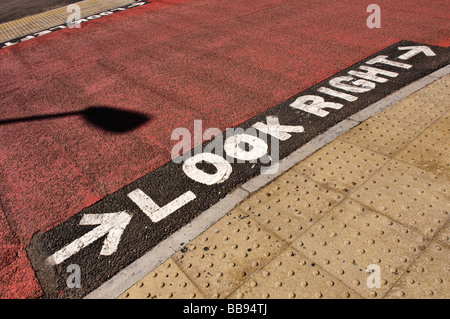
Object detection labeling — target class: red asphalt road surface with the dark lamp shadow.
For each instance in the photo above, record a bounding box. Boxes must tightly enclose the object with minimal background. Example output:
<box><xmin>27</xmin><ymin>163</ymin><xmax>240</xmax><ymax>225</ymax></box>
<box><xmin>0</xmin><ymin>0</ymin><xmax>450</xmax><ymax>298</ymax></box>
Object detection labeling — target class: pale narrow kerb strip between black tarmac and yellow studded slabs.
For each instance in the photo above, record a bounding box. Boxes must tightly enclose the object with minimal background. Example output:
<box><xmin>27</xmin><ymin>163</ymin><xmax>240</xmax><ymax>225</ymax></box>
<box><xmin>85</xmin><ymin>64</ymin><xmax>450</xmax><ymax>299</ymax></box>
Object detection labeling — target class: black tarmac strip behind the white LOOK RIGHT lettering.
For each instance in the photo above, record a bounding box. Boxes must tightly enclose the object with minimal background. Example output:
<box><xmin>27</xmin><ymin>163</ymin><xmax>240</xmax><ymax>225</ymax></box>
<box><xmin>27</xmin><ymin>41</ymin><xmax>450</xmax><ymax>298</ymax></box>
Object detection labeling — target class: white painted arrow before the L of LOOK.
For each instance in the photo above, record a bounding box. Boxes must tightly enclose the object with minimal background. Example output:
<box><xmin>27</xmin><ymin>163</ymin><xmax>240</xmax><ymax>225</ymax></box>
<box><xmin>46</xmin><ymin>211</ymin><xmax>132</xmax><ymax>266</ymax></box>
